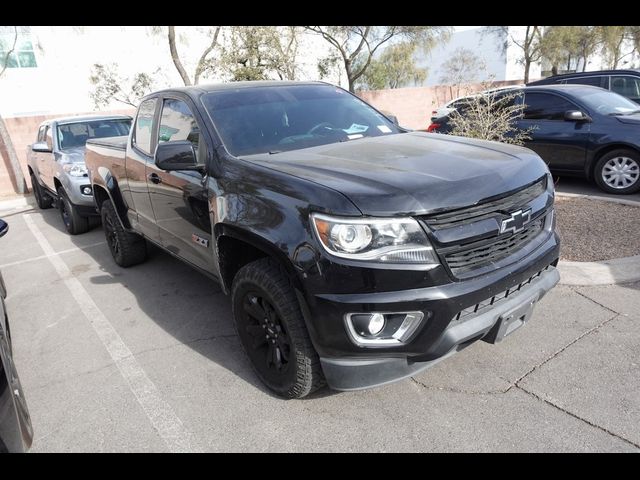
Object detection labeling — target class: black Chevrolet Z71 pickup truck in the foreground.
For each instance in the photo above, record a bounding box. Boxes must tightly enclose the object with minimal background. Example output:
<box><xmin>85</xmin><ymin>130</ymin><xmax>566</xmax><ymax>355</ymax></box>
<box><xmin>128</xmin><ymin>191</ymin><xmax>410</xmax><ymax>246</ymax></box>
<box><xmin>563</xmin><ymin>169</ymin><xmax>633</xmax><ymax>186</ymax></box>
<box><xmin>86</xmin><ymin>82</ymin><xmax>559</xmax><ymax>398</ymax></box>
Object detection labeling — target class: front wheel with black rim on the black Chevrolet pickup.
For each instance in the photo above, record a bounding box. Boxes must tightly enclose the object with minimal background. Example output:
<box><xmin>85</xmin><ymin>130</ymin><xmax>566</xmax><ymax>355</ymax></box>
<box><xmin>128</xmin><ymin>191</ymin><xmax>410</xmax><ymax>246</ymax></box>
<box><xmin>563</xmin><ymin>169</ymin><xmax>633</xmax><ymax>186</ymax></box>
<box><xmin>231</xmin><ymin>258</ymin><xmax>325</xmax><ymax>398</ymax></box>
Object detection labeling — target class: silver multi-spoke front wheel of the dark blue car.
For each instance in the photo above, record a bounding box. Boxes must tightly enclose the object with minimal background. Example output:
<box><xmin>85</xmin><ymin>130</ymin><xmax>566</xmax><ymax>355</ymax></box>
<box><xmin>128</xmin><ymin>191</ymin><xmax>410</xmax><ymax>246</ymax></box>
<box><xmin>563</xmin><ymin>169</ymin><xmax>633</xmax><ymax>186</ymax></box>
<box><xmin>594</xmin><ymin>148</ymin><xmax>640</xmax><ymax>195</ymax></box>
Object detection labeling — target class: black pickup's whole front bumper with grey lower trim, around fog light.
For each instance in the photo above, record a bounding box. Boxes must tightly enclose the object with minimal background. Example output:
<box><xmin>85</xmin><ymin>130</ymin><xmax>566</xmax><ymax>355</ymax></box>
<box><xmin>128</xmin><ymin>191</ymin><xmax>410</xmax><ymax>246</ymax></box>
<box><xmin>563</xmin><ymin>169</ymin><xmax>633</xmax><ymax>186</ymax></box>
<box><xmin>299</xmin><ymin>228</ymin><xmax>560</xmax><ymax>390</ymax></box>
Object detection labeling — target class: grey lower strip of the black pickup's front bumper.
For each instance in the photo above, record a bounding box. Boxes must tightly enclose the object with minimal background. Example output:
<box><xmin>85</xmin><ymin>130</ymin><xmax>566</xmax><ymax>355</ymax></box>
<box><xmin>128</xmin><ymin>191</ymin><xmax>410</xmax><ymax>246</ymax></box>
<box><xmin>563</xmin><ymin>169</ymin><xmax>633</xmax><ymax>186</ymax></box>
<box><xmin>320</xmin><ymin>266</ymin><xmax>560</xmax><ymax>390</ymax></box>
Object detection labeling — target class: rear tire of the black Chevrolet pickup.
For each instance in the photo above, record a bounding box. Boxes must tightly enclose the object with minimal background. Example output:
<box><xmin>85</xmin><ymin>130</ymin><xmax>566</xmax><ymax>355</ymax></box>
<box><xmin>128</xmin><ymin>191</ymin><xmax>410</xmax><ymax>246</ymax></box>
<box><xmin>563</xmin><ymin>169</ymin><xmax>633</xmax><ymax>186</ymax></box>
<box><xmin>100</xmin><ymin>200</ymin><xmax>147</xmax><ymax>268</ymax></box>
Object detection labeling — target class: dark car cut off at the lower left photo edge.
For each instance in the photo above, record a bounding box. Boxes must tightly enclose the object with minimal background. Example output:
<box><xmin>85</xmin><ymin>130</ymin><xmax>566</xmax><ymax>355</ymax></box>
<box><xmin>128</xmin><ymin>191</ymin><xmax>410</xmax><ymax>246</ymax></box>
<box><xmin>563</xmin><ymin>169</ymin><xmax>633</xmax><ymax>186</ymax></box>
<box><xmin>0</xmin><ymin>220</ymin><xmax>33</xmax><ymax>453</ymax></box>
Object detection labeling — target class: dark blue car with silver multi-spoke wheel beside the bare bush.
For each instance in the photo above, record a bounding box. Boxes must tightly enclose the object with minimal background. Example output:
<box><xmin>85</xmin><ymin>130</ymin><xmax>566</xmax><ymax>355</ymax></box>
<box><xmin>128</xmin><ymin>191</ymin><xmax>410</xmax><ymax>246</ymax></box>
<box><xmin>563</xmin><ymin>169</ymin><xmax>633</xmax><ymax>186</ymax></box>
<box><xmin>432</xmin><ymin>85</ymin><xmax>640</xmax><ymax>194</ymax></box>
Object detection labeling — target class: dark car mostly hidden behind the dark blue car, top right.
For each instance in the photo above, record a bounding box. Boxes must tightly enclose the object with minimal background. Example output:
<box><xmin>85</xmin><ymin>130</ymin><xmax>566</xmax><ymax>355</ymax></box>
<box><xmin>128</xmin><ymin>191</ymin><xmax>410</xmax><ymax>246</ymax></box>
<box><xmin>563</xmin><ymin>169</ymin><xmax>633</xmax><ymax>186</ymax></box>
<box><xmin>527</xmin><ymin>70</ymin><xmax>640</xmax><ymax>103</ymax></box>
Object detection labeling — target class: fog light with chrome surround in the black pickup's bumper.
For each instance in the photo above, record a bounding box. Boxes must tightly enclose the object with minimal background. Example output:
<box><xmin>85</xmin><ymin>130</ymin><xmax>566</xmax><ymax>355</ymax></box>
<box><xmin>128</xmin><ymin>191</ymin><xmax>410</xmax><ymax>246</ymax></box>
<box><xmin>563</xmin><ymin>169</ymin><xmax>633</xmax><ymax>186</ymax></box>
<box><xmin>345</xmin><ymin>312</ymin><xmax>429</xmax><ymax>347</ymax></box>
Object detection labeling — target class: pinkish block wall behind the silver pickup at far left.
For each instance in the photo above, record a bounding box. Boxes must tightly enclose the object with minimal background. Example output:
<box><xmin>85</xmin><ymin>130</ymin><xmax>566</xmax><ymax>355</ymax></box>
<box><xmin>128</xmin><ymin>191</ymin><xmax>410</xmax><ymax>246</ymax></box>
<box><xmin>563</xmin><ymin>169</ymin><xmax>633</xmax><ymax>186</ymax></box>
<box><xmin>0</xmin><ymin>108</ymin><xmax>135</xmax><ymax>197</ymax></box>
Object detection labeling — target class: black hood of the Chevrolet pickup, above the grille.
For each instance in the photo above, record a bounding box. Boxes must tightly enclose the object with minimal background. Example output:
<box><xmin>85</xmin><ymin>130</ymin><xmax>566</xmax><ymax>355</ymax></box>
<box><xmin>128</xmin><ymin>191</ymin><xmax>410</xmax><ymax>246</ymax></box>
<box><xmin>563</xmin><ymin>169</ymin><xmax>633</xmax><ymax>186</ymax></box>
<box><xmin>243</xmin><ymin>132</ymin><xmax>548</xmax><ymax>216</ymax></box>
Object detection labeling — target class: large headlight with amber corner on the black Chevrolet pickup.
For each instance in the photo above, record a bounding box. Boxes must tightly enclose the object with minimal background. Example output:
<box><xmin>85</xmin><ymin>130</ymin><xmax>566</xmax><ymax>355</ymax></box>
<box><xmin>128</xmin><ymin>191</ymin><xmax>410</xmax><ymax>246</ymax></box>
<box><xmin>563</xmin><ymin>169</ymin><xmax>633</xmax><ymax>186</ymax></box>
<box><xmin>311</xmin><ymin>213</ymin><xmax>439</xmax><ymax>267</ymax></box>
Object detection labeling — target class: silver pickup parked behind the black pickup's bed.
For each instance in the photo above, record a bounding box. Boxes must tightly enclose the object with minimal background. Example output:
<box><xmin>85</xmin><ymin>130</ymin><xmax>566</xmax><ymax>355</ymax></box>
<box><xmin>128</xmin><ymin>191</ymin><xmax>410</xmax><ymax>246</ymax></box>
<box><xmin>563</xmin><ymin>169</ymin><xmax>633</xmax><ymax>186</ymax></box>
<box><xmin>28</xmin><ymin>115</ymin><xmax>131</xmax><ymax>235</ymax></box>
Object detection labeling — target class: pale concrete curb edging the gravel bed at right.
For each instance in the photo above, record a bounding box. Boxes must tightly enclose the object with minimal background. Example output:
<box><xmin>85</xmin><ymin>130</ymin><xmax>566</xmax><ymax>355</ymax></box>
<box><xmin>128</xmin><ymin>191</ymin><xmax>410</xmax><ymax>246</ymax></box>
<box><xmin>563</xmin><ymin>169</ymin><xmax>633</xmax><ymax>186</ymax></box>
<box><xmin>556</xmin><ymin>192</ymin><xmax>640</xmax><ymax>286</ymax></box>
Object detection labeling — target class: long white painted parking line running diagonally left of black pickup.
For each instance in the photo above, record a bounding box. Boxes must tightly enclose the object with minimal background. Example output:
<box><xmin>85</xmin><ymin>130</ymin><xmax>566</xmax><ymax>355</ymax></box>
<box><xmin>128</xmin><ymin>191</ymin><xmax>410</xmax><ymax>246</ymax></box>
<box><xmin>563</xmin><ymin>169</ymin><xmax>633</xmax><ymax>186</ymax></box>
<box><xmin>22</xmin><ymin>215</ymin><xmax>200</xmax><ymax>452</ymax></box>
